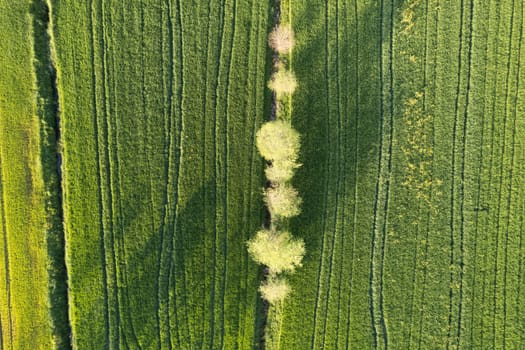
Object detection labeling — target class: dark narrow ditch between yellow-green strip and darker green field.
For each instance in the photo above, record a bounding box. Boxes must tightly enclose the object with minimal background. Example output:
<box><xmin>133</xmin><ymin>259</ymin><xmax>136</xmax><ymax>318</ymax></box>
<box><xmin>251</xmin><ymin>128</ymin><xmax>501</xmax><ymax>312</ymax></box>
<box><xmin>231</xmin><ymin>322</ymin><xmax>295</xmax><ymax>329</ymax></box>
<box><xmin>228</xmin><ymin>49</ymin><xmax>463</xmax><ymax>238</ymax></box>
<box><xmin>30</xmin><ymin>0</ymin><xmax>71</xmax><ymax>349</ymax></box>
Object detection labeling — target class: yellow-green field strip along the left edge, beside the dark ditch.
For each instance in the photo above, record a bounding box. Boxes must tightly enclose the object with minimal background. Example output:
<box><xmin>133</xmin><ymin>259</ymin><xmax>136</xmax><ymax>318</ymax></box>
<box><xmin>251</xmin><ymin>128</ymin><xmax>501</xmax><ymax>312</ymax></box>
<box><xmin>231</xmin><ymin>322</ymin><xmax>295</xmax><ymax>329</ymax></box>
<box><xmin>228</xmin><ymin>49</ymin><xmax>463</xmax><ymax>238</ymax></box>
<box><xmin>0</xmin><ymin>1</ymin><xmax>53</xmax><ymax>349</ymax></box>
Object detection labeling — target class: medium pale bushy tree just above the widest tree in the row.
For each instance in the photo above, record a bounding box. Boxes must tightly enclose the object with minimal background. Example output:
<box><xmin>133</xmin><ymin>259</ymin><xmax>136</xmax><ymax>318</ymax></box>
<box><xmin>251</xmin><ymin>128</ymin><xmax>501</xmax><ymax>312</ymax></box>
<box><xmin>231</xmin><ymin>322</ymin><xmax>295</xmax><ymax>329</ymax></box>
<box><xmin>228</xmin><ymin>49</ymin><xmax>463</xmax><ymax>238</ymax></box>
<box><xmin>264</xmin><ymin>185</ymin><xmax>302</xmax><ymax>218</ymax></box>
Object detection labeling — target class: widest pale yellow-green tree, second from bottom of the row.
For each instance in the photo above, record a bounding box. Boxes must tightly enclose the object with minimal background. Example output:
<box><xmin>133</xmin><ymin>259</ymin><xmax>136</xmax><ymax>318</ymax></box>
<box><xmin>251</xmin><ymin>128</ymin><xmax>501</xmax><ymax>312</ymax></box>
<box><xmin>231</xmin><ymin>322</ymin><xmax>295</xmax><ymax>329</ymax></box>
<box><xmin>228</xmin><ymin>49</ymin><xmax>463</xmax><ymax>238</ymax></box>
<box><xmin>248</xmin><ymin>230</ymin><xmax>305</xmax><ymax>275</ymax></box>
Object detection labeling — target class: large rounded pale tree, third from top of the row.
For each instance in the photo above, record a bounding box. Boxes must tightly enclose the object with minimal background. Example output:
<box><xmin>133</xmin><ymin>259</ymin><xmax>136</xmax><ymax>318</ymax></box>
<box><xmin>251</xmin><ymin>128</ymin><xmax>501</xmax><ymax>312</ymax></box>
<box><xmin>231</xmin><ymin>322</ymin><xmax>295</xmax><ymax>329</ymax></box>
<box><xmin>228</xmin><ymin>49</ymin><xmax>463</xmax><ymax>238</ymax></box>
<box><xmin>256</xmin><ymin>120</ymin><xmax>300</xmax><ymax>163</ymax></box>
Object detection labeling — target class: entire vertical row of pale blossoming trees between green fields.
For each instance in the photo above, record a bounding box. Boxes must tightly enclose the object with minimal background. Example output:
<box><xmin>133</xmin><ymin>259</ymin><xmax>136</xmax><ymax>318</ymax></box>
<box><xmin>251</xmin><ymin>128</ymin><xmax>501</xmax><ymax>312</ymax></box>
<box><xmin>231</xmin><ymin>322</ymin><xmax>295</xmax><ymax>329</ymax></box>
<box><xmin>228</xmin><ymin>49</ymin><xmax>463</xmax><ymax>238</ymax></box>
<box><xmin>248</xmin><ymin>25</ymin><xmax>305</xmax><ymax>304</ymax></box>
